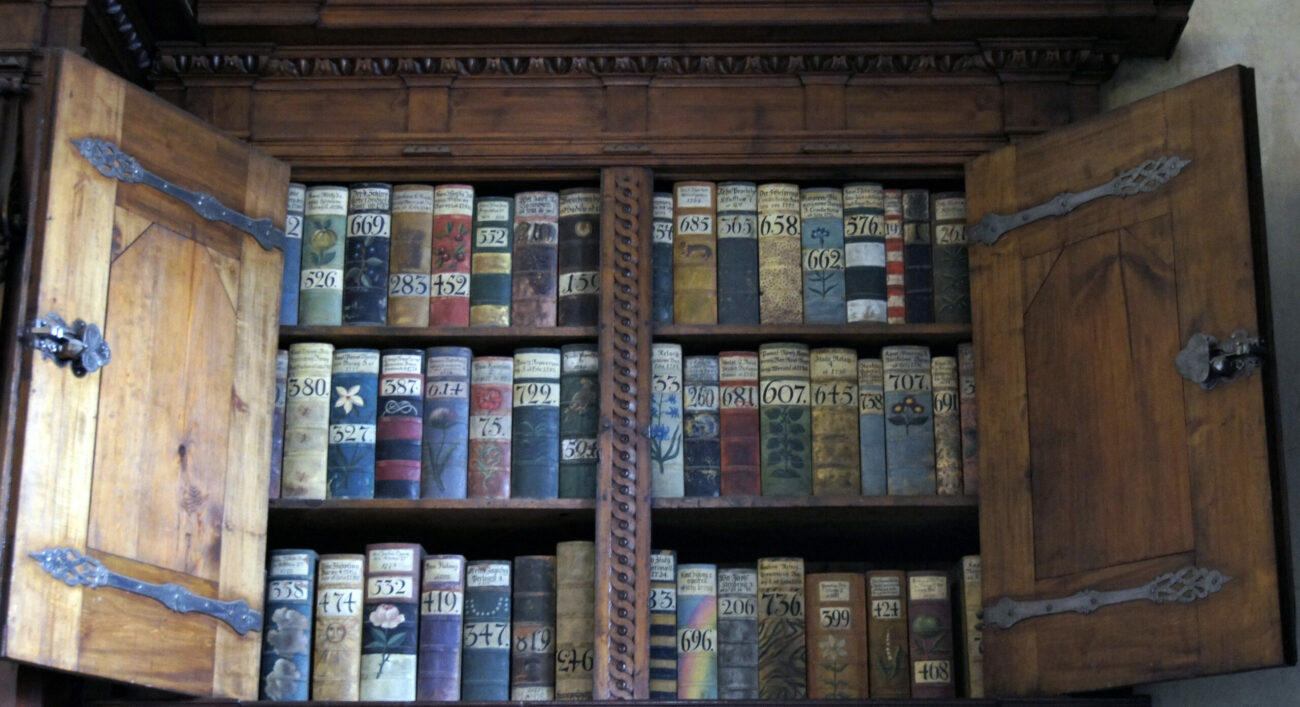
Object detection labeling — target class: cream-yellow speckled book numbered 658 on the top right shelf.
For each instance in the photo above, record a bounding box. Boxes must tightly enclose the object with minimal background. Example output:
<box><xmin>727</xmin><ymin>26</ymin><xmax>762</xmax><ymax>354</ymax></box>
<box><xmin>758</xmin><ymin>183</ymin><xmax>803</xmax><ymax>324</ymax></box>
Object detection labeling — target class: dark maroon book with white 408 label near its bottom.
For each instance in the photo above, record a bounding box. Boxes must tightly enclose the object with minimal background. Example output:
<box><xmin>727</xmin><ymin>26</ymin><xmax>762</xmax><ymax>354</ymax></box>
<box><xmin>907</xmin><ymin>571</ymin><xmax>957</xmax><ymax>698</ymax></box>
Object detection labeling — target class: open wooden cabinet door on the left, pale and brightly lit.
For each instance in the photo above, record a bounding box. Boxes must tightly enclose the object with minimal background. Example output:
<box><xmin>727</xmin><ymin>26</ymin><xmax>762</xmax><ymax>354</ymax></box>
<box><xmin>4</xmin><ymin>53</ymin><xmax>289</xmax><ymax>698</ymax></box>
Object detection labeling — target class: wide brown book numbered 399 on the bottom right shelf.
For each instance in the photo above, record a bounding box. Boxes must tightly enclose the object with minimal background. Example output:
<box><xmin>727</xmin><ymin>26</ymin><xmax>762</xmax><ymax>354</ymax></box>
<box><xmin>803</xmin><ymin>572</ymin><xmax>868</xmax><ymax>699</ymax></box>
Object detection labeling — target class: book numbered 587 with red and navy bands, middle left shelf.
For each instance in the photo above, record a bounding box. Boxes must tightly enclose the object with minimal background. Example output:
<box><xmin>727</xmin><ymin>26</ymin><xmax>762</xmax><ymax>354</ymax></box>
<box><xmin>374</xmin><ymin>348</ymin><xmax>424</xmax><ymax>498</ymax></box>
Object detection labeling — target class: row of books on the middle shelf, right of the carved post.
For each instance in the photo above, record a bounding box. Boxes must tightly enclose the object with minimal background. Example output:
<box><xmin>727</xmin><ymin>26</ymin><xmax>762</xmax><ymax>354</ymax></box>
<box><xmin>649</xmin><ymin>343</ymin><xmax>979</xmax><ymax>498</ymax></box>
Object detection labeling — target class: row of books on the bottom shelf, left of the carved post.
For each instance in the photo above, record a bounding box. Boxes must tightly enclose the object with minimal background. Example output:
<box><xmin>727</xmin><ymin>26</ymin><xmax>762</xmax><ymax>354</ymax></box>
<box><xmin>259</xmin><ymin>541</ymin><xmax>595</xmax><ymax>702</ymax></box>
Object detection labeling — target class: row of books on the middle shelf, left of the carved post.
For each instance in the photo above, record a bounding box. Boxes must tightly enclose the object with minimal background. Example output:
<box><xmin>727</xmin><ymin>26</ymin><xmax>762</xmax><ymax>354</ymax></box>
<box><xmin>270</xmin><ymin>343</ymin><xmax>599</xmax><ymax>499</ymax></box>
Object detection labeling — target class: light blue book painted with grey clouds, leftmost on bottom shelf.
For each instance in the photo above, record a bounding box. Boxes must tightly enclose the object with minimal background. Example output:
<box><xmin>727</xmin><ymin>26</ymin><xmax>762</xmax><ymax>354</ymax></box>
<box><xmin>259</xmin><ymin>550</ymin><xmax>316</xmax><ymax>701</ymax></box>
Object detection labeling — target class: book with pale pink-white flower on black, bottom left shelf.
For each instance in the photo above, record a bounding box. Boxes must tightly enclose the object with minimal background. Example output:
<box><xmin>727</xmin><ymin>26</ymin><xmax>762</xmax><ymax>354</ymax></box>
<box><xmin>360</xmin><ymin>542</ymin><xmax>424</xmax><ymax>702</ymax></box>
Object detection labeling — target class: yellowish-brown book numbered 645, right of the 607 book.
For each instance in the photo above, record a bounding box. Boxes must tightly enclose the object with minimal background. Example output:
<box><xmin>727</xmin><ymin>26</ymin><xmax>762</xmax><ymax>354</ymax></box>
<box><xmin>810</xmin><ymin>348</ymin><xmax>862</xmax><ymax>496</ymax></box>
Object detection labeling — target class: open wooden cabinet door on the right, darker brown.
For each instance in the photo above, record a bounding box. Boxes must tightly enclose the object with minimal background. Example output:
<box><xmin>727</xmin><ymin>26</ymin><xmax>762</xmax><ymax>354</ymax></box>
<box><xmin>966</xmin><ymin>68</ymin><xmax>1291</xmax><ymax>694</ymax></box>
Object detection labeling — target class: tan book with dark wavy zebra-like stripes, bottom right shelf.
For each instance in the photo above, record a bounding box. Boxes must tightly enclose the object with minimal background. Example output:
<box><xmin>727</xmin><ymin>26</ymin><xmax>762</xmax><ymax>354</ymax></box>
<box><xmin>758</xmin><ymin>558</ymin><xmax>807</xmax><ymax>699</ymax></box>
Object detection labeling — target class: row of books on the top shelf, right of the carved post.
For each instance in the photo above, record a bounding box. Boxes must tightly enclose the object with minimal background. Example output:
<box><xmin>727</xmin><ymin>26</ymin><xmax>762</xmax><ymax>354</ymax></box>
<box><xmin>653</xmin><ymin>182</ymin><xmax>970</xmax><ymax>325</ymax></box>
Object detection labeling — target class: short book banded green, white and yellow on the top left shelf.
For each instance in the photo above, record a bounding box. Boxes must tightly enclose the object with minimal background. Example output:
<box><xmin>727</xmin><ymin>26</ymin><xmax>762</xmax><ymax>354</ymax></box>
<box><xmin>469</xmin><ymin>196</ymin><xmax>515</xmax><ymax>326</ymax></box>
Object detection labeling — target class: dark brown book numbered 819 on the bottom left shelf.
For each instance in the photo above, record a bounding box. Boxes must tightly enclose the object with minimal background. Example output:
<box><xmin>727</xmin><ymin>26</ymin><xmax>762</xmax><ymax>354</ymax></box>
<box><xmin>510</xmin><ymin>555</ymin><xmax>555</xmax><ymax>702</ymax></box>
